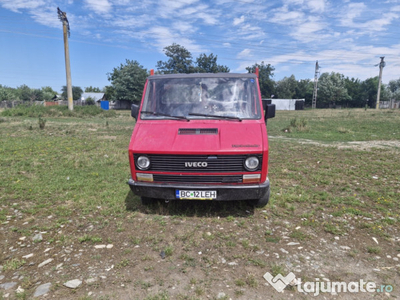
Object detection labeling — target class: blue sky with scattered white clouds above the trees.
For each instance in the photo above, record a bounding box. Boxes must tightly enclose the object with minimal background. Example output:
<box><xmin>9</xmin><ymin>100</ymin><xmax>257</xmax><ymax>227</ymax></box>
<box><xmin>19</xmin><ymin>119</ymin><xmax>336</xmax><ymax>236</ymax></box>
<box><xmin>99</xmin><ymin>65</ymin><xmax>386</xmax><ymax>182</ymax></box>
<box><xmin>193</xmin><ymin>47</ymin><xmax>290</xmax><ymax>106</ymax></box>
<box><xmin>0</xmin><ymin>0</ymin><xmax>400</xmax><ymax>91</ymax></box>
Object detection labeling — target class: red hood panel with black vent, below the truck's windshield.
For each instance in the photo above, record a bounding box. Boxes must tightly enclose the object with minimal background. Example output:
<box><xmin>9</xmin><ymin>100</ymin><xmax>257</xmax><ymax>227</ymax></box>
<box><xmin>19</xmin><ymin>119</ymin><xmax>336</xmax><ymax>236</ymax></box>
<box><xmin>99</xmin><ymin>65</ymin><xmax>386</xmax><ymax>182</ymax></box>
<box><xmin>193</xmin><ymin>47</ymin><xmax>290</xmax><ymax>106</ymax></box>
<box><xmin>129</xmin><ymin>121</ymin><xmax>265</xmax><ymax>154</ymax></box>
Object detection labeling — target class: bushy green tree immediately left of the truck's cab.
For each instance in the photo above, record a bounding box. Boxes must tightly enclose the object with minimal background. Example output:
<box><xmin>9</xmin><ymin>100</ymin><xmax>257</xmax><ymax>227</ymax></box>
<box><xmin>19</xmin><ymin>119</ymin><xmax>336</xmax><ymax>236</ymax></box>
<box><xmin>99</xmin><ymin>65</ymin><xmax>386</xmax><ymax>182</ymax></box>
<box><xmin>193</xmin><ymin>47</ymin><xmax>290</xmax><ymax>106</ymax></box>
<box><xmin>106</xmin><ymin>59</ymin><xmax>148</xmax><ymax>102</ymax></box>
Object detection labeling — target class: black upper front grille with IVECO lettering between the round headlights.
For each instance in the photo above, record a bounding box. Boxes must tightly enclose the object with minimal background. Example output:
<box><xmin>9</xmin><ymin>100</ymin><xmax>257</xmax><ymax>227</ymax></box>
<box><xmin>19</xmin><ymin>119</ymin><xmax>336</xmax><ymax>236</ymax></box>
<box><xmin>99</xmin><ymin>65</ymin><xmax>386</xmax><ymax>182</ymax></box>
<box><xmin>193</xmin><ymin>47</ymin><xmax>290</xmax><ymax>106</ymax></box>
<box><xmin>134</xmin><ymin>154</ymin><xmax>262</xmax><ymax>173</ymax></box>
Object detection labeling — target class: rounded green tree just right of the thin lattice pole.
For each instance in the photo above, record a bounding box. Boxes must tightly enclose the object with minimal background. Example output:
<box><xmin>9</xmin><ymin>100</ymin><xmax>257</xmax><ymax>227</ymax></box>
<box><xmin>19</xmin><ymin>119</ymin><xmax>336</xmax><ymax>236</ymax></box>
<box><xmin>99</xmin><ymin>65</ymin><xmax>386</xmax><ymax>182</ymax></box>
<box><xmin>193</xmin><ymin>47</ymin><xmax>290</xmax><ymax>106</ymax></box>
<box><xmin>317</xmin><ymin>72</ymin><xmax>351</xmax><ymax>107</ymax></box>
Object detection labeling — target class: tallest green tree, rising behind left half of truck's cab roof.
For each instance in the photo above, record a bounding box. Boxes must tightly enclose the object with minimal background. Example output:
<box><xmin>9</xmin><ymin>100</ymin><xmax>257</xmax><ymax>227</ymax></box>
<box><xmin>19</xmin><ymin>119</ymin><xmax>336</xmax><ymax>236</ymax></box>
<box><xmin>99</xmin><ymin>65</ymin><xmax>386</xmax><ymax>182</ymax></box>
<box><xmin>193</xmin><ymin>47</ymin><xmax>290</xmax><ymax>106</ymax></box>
<box><xmin>157</xmin><ymin>43</ymin><xmax>195</xmax><ymax>74</ymax></box>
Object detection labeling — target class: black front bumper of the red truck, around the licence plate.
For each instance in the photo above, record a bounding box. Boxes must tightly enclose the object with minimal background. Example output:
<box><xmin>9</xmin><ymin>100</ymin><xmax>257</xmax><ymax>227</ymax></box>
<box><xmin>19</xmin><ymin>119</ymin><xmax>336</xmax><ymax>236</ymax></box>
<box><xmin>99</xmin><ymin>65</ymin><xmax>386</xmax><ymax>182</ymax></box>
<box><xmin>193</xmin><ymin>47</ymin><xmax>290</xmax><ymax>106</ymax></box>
<box><xmin>127</xmin><ymin>178</ymin><xmax>269</xmax><ymax>201</ymax></box>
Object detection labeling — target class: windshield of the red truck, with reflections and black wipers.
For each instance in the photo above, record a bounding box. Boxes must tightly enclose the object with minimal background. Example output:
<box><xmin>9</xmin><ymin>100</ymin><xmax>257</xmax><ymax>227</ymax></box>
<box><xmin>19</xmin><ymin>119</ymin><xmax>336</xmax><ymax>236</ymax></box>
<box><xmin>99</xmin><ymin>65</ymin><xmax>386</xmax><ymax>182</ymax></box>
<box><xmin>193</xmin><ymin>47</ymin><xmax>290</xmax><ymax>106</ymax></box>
<box><xmin>141</xmin><ymin>77</ymin><xmax>261</xmax><ymax>120</ymax></box>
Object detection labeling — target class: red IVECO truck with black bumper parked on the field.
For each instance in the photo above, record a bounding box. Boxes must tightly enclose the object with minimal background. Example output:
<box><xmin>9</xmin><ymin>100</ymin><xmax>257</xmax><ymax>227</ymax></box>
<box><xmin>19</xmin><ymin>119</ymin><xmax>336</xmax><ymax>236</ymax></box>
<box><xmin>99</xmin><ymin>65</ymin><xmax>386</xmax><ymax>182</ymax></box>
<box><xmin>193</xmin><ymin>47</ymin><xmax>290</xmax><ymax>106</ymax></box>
<box><xmin>128</xmin><ymin>72</ymin><xmax>275</xmax><ymax>207</ymax></box>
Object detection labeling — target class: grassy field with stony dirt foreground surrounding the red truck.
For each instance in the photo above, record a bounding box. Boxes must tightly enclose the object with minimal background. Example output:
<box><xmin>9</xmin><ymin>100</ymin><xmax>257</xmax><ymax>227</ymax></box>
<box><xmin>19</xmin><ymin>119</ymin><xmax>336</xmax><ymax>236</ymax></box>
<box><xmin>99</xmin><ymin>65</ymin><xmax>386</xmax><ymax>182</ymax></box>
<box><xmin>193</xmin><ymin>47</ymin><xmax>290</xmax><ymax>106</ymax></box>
<box><xmin>0</xmin><ymin>108</ymin><xmax>400</xmax><ymax>299</ymax></box>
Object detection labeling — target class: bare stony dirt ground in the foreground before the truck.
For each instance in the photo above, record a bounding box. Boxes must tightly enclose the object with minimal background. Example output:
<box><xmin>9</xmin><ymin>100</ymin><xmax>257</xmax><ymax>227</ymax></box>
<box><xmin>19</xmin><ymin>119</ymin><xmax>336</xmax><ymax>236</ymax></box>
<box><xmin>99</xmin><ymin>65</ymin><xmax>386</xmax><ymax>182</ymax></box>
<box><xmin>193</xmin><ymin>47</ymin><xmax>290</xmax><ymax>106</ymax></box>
<box><xmin>0</xmin><ymin>199</ymin><xmax>400</xmax><ymax>299</ymax></box>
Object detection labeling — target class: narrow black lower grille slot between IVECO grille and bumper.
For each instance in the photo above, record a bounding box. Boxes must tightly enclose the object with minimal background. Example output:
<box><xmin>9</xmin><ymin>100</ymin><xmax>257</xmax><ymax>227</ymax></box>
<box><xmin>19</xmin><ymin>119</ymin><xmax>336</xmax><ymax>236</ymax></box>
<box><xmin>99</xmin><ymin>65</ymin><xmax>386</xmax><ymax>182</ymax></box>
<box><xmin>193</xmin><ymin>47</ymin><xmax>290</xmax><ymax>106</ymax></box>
<box><xmin>153</xmin><ymin>174</ymin><xmax>242</xmax><ymax>183</ymax></box>
